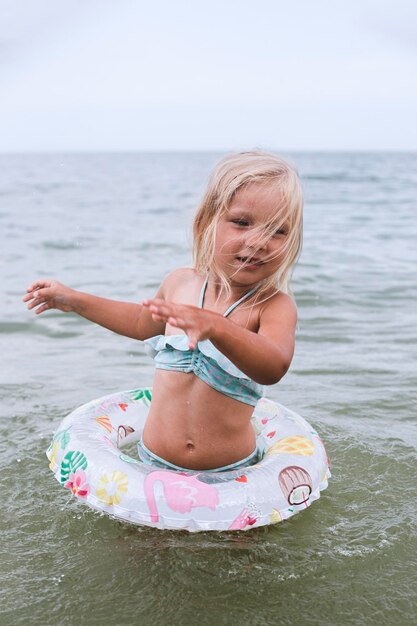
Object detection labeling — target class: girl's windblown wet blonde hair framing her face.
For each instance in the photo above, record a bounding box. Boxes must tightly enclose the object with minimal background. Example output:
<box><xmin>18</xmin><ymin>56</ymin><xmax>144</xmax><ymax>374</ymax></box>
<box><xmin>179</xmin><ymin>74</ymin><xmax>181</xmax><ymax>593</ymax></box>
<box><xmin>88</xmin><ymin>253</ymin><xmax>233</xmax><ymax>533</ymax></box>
<box><xmin>193</xmin><ymin>151</ymin><xmax>303</xmax><ymax>302</ymax></box>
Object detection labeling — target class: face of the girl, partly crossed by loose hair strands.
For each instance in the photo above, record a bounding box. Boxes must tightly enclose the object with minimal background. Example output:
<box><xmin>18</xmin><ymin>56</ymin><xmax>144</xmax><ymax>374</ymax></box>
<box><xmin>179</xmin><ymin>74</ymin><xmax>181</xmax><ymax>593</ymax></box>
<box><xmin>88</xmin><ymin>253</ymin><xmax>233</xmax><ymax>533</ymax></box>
<box><xmin>215</xmin><ymin>183</ymin><xmax>288</xmax><ymax>285</ymax></box>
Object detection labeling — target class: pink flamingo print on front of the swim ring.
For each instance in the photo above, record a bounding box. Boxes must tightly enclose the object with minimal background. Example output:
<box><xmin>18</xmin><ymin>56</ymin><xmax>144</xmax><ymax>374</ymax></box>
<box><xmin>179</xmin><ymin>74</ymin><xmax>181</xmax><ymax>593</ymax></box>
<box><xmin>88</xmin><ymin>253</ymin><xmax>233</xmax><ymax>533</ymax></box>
<box><xmin>144</xmin><ymin>470</ymin><xmax>219</xmax><ymax>523</ymax></box>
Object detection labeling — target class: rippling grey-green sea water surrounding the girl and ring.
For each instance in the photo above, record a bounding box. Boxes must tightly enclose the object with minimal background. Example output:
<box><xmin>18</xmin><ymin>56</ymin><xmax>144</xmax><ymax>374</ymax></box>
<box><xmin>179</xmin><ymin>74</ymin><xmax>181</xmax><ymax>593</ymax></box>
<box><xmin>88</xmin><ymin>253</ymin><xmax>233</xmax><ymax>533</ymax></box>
<box><xmin>0</xmin><ymin>153</ymin><xmax>417</xmax><ymax>626</ymax></box>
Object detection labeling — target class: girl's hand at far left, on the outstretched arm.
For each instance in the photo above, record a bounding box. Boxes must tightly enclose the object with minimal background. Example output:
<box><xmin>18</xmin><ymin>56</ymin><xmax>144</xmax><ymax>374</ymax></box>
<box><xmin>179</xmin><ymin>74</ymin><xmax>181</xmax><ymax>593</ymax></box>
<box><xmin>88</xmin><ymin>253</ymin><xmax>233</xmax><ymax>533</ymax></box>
<box><xmin>23</xmin><ymin>280</ymin><xmax>77</xmax><ymax>315</ymax></box>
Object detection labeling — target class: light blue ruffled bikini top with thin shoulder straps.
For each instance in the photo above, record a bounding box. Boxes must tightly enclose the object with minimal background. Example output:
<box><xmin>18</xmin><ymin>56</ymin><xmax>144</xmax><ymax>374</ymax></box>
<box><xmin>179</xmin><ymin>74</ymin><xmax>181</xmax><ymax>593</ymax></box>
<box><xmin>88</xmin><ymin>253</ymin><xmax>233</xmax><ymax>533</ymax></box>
<box><xmin>144</xmin><ymin>277</ymin><xmax>264</xmax><ymax>406</ymax></box>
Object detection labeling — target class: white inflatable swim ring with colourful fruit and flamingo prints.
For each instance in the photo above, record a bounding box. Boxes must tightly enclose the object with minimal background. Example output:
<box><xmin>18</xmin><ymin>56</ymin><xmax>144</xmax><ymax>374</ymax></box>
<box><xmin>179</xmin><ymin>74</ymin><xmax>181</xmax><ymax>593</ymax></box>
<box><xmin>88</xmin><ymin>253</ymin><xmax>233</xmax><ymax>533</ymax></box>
<box><xmin>47</xmin><ymin>388</ymin><xmax>330</xmax><ymax>532</ymax></box>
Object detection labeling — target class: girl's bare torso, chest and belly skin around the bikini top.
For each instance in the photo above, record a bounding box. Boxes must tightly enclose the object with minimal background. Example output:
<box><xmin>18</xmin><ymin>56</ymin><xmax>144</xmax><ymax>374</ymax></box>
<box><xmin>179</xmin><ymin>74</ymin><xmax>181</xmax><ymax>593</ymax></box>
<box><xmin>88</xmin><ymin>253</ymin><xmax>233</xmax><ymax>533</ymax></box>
<box><xmin>143</xmin><ymin>269</ymin><xmax>260</xmax><ymax>469</ymax></box>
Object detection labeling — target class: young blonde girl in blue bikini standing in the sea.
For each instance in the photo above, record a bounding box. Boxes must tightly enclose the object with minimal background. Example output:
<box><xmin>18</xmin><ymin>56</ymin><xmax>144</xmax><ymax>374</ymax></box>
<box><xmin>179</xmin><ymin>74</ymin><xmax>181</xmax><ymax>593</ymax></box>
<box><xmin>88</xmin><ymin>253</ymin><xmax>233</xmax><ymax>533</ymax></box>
<box><xmin>23</xmin><ymin>151</ymin><xmax>303</xmax><ymax>471</ymax></box>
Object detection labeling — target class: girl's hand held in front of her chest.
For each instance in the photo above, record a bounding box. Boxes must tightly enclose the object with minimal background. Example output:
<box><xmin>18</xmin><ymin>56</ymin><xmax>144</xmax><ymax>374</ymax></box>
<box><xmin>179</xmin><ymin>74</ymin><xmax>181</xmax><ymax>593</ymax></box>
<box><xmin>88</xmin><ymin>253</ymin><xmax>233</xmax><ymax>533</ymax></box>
<box><xmin>142</xmin><ymin>298</ymin><xmax>218</xmax><ymax>350</ymax></box>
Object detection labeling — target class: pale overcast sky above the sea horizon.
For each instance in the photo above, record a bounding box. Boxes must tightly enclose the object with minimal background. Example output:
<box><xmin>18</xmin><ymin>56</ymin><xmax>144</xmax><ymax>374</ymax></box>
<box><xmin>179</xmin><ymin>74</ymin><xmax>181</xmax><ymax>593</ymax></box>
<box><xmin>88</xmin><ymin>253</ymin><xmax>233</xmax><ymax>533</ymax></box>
<box><xmin>0</xmin><ymin>0</ymin><xmax>417</xmax><ymax>151</ymax></box>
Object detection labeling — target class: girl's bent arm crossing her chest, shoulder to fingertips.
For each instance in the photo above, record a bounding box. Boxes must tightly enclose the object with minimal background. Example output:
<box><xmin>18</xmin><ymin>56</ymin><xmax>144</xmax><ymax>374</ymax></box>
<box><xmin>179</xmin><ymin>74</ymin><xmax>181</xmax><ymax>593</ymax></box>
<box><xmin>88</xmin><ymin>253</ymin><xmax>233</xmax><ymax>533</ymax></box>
<box><xmin>143</xmin><ymin>293</ymin><xmax>297</xmax><ymax>385</ymax></box>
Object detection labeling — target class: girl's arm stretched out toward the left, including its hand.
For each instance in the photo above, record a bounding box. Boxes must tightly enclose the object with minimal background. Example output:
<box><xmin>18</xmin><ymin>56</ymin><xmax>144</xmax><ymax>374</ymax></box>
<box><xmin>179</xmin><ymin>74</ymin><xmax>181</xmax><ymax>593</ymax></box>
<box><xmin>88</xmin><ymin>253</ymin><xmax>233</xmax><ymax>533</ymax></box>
<box><xmin>23</xmin><ymin>280</ymin><xmax>165</xmax><ymax>340</ymax></box>
